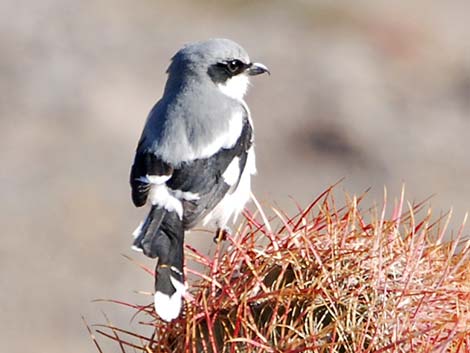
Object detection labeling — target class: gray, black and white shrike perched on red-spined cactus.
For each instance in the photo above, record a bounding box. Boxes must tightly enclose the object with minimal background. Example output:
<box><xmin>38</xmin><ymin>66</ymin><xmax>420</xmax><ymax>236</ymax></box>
<box><xmin>130</xmin><ymin>39</ymin><xmax>269</xmax><ymax>321</ymax></box>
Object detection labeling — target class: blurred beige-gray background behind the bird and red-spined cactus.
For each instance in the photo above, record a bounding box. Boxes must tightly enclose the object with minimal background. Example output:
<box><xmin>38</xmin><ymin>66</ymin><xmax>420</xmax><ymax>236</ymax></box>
<box><xmin>0</xmin><ymin>0</ymin><xmax>470</xmax><ymax>353</ymax></box>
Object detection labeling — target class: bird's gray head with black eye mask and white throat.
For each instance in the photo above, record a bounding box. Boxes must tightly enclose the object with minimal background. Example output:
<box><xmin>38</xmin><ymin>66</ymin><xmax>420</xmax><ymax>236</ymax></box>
<box><xmin>168</xmin><ymin>39</ymin><xmax>269</xmax><ymax>100</ymax></box>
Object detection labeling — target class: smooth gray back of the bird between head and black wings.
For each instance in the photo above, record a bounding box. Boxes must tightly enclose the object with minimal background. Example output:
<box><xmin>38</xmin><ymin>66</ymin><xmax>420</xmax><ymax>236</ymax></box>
<box><xmin>140</xmin><ymin>81</ymin><xmax>246</xmax><ymax>166</ymax></box>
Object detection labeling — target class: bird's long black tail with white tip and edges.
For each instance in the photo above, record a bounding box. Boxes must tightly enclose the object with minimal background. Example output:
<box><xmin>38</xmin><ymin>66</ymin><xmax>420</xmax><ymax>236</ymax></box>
<box><xmin>133</xmin><ymin>206</ymin><xmax>185</xmax><ymax>321</ymax></box>
